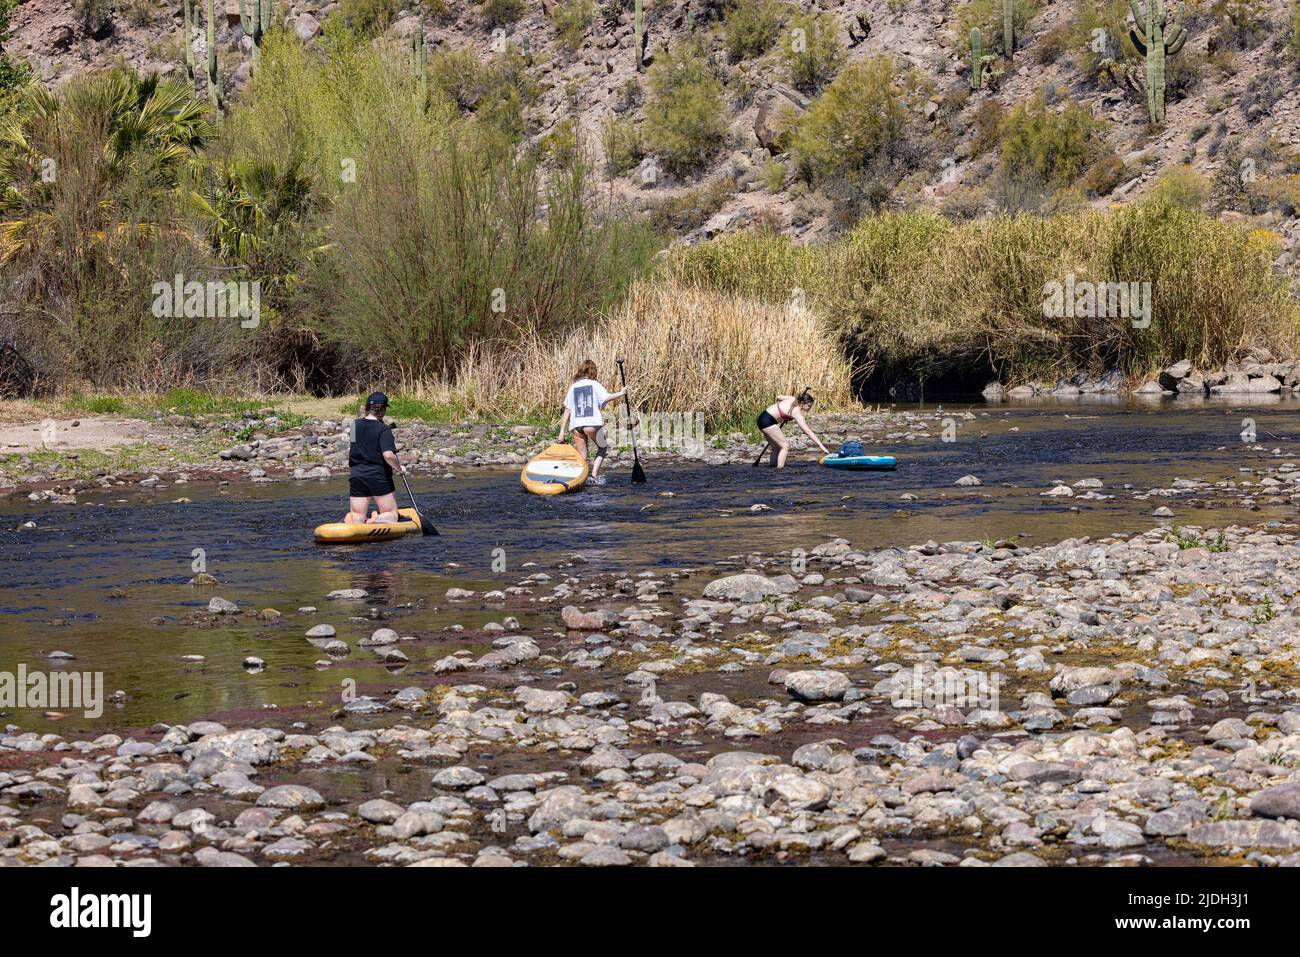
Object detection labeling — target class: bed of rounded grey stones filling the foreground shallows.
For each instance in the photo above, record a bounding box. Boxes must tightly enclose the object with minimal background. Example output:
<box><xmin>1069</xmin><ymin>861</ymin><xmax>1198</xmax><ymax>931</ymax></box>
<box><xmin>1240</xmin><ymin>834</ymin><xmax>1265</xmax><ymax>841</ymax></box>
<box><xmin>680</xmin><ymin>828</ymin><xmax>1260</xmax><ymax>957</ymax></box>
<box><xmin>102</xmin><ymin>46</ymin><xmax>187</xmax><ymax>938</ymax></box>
<box><xmin>0</xmin><ymin>524</ymin><xmax>1300</xmax><ymax>866</ymax></box>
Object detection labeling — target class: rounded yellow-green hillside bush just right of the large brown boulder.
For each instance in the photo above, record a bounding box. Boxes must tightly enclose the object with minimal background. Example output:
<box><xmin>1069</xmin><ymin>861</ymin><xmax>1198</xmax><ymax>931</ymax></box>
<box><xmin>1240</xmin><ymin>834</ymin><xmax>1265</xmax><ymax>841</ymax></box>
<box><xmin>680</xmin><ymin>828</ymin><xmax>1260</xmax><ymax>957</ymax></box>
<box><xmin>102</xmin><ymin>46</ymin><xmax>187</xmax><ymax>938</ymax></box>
<box><xmin>788</xmin><ymin>56</ymin><xmax>931</xmax><ymax>182</ymax></box>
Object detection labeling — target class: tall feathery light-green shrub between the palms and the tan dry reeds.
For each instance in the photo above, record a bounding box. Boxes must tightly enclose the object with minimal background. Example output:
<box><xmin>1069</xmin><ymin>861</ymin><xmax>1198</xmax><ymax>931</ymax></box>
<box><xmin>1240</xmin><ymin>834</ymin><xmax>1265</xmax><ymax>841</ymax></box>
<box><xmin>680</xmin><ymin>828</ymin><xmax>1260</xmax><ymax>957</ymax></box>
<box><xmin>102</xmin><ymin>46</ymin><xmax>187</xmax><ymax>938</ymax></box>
<box><xmin>226</xmin><ymin>27</ymin><xmax>655</xmax><ymax>390</ymax></box>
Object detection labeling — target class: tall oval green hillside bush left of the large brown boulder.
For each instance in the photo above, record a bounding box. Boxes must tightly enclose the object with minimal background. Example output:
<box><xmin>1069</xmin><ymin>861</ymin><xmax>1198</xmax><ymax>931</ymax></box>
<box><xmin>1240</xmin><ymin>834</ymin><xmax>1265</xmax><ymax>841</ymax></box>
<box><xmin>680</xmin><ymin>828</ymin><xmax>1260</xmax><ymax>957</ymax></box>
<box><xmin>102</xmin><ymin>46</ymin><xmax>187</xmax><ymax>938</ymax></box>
<box><xmin>644</xmin><ymin>43</ymin><xmax>727</xmax><ymax>176</ymax></box>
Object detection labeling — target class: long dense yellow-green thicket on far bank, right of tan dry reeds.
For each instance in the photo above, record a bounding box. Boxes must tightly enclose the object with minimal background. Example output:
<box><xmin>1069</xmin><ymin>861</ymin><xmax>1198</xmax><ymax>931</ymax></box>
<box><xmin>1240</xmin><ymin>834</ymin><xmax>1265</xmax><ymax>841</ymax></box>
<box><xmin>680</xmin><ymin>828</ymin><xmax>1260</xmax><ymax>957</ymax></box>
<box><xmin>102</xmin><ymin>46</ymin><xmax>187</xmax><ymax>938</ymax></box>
<box><xmin>668</xmin><ymin>199</ymin><xmax>1300</xmax><ymax>381</ymax></box>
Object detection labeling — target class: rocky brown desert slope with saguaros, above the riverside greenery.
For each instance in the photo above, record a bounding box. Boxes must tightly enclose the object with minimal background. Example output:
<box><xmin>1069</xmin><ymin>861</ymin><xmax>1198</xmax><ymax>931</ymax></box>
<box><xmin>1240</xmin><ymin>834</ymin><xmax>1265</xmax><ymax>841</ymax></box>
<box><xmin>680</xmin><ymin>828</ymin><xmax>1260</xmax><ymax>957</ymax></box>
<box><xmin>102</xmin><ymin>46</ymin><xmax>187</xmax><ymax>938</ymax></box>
<box><xmin>5</xmin><ymin>0</ymin><xmax>1300</xmax><ymax>248</ymax></box>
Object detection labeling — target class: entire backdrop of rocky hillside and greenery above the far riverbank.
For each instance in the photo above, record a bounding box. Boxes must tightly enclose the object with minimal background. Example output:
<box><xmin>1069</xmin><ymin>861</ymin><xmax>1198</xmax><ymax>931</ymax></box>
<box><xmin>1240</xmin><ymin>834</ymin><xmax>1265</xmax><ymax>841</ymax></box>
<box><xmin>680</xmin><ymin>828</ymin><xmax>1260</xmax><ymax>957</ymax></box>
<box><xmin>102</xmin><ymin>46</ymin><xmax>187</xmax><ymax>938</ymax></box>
<box><xmin>0</xmin><ymin>0</ymin><xmax>1300</xmax><ymax>403</ymax></box>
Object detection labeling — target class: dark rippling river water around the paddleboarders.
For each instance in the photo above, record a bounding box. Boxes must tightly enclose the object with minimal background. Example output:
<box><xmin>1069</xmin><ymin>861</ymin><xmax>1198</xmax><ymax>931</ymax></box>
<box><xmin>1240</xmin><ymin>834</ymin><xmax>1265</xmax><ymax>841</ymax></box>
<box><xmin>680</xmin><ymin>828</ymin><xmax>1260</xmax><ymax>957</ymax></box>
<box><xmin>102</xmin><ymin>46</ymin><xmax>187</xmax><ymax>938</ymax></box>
<box><xmin>0</xmin><ymin>400</ymin><xmax>1300</xmax><ymax>735</ymax></box>
